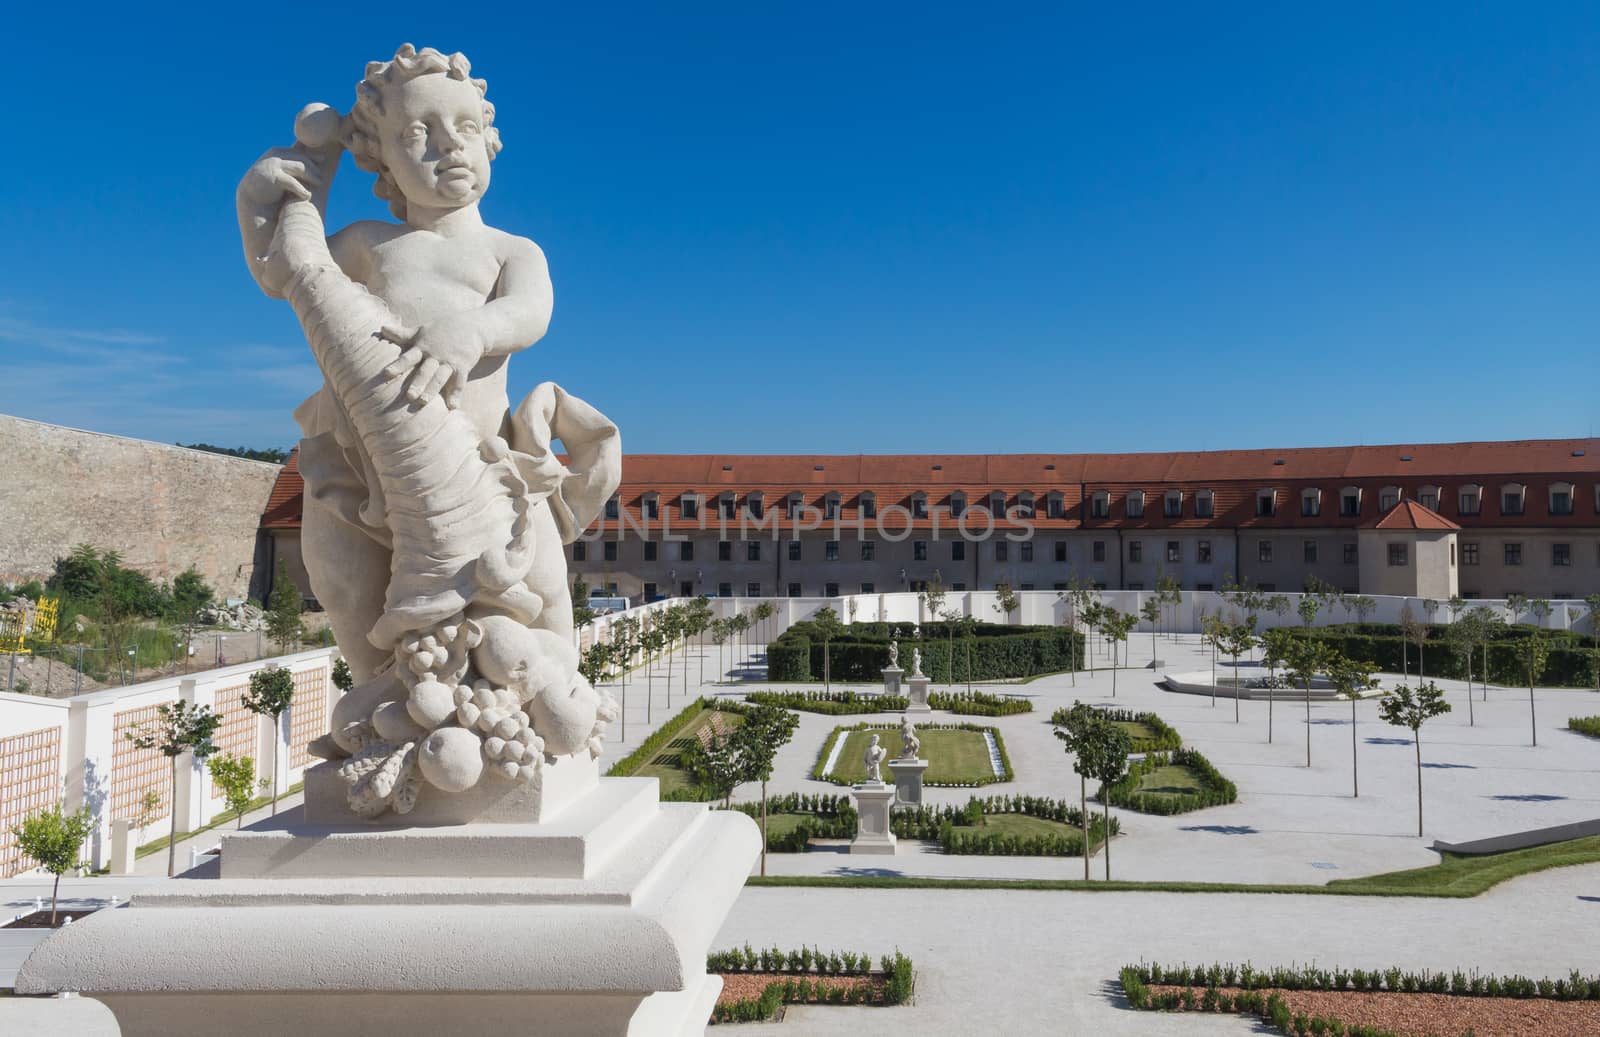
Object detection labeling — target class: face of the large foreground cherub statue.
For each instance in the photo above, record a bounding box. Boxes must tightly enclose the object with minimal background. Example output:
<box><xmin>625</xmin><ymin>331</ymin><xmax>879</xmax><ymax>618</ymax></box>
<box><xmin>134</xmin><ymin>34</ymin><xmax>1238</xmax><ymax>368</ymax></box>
<box><xmin>379</xmin><ymin>75</ymin><xmax>490</xmax><ymax>208</ymax></box>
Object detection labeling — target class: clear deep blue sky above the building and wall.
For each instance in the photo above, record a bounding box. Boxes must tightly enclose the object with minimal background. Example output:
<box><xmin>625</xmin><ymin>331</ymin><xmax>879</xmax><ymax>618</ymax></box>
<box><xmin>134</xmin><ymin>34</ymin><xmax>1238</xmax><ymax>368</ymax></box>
<box><xmin>0</xmin><ymin>3</ymin><xmax>1600</xmax><ymax>453</ymax></box>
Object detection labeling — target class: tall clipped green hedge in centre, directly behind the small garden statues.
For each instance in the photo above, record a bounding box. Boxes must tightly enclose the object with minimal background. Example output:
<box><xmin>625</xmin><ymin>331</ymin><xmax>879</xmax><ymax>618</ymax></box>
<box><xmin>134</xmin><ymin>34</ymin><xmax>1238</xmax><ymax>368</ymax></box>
<box><xmin>766</xmin><ymin>621</ymin><xmax>1083</xmax><ymax>683</ymax></box>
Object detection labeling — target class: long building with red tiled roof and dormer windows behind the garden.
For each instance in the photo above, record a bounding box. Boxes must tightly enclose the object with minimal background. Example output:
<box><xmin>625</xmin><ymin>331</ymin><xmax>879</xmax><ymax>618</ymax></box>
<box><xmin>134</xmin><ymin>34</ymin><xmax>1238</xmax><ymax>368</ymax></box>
<box><xmin>262</xmin><ymin>438</ymin><xmax>1600</xmax><ymax>600</ymax></box>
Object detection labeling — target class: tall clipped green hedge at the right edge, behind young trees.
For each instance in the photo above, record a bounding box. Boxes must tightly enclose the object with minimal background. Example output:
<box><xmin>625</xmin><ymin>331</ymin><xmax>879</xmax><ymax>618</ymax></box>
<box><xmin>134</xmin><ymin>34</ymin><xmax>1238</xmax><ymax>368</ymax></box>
<box><xmin>1282</xmin><ymin>624</ymin><xmax>1600</xmax><ymax>688</ymax></box>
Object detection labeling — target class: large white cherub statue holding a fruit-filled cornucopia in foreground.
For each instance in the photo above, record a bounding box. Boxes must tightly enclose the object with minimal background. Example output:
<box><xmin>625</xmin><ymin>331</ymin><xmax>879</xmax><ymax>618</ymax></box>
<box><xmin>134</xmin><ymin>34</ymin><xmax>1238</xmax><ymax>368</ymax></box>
<box><xmin>237</xmin><ymin>43</ymin><xmax>621</xmax><ymax>816</ymax></box>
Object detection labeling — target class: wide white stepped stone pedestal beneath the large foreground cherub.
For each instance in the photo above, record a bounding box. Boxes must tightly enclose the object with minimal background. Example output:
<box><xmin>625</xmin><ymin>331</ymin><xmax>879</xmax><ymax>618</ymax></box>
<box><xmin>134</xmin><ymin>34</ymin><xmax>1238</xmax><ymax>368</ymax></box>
<box><xmin>16</xmin><ymin>778</ymin><xmax>755</xmax><ymax>1037</ymax></box>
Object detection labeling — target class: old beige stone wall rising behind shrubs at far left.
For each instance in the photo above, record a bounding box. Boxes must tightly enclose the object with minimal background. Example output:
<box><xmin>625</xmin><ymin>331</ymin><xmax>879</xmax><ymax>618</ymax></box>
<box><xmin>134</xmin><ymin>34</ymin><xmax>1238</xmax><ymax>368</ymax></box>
<box><xmin>0</xmin><ymin>414</ymin><xmax>278</xmax><ymax>599</ymax></box>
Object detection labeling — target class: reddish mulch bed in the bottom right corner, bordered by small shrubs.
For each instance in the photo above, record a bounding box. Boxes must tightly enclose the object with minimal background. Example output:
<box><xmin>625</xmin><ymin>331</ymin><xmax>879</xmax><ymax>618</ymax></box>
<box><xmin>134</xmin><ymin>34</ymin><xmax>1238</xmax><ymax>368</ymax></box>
<box><xmin>1150</xmin><ymin>986</ymin><xmax>1600</xmax><ymax>1037</ymax></box>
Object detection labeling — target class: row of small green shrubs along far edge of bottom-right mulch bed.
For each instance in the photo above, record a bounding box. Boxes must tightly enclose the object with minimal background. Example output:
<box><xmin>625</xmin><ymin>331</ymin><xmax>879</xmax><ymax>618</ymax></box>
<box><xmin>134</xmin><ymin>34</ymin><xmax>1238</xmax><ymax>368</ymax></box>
<box><xmin>1123</xmin><ymin>962</ymin><xmax>1600</xmax><ymax>1000</ymax></box>
